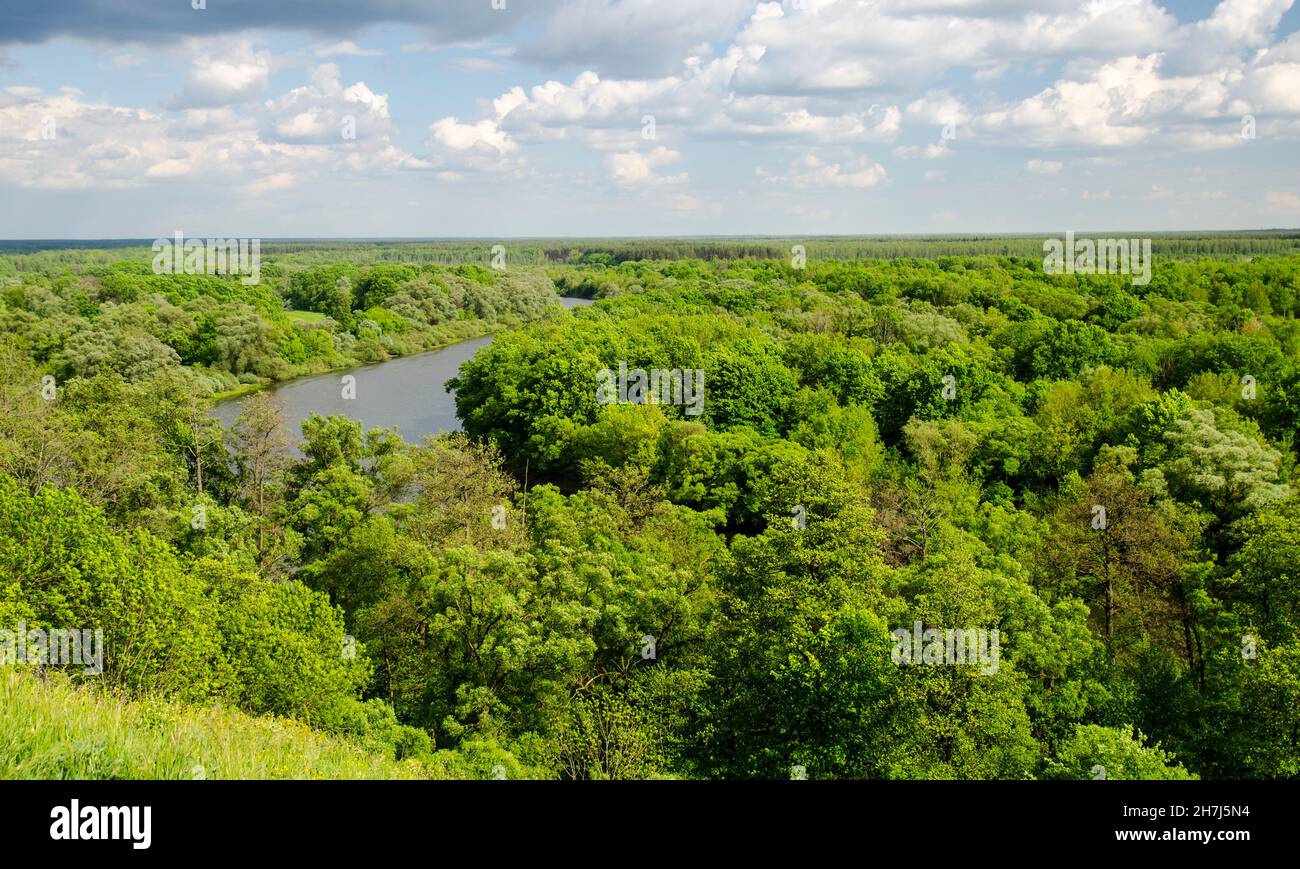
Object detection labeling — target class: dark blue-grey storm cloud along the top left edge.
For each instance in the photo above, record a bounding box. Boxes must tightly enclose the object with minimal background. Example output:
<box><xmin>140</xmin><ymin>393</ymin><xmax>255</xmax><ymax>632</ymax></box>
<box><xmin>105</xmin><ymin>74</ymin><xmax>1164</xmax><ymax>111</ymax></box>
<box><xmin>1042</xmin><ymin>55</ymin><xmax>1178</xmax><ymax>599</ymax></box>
<box><xmin>0</xmin><ymin>0</ymin><xmax>559</xmax><ymax>43</ymax></box>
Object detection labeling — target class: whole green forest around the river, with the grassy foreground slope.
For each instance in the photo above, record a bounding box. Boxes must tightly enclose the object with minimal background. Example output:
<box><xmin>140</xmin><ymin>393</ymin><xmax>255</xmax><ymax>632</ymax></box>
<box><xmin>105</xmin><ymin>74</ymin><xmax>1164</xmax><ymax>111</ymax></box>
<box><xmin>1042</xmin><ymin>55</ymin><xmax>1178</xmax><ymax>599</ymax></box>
<box><xmin>0</xmin><ymin>234</ymin><xmax>1300</xmax><ymax>779</ymax></box>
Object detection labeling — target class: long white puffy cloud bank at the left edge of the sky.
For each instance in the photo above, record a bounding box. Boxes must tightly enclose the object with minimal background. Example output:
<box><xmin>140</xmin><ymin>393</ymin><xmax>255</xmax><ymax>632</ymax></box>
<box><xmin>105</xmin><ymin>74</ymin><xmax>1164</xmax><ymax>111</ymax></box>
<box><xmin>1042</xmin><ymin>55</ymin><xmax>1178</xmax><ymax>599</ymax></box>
<box><xmin>0</xmin><ymin>64</ymin><xmax>432</xmax><ymax>194</ymax></box>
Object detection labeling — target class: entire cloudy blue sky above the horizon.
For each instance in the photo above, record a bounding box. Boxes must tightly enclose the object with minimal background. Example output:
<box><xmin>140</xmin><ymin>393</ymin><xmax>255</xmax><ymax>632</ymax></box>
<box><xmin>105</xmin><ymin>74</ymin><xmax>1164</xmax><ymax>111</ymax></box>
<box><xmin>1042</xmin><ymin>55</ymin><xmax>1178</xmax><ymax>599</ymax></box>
<box><xmin>0</xmin><ymin>0</ymin><xmax>1300</xmax><ymax>238</ymax></box>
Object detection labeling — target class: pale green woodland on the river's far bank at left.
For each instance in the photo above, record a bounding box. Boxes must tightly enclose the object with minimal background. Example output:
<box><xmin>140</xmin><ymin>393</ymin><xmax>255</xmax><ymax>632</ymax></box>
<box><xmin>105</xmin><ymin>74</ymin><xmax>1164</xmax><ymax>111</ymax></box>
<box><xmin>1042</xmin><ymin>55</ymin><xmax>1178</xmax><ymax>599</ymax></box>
<box><xmin>0</xmin><ymin>251</ymin><xmax>558</xmax><ymax>393</ymax></box>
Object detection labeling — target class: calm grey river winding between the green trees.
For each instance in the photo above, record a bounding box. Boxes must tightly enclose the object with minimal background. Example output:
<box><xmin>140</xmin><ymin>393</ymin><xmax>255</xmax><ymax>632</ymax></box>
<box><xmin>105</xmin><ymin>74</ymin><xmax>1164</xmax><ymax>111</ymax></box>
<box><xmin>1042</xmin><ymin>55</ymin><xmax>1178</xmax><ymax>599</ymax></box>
<box><xmin>213</xmin><ymin>298</ymin><xmax>592</xmax><ymax>444</ymax></box>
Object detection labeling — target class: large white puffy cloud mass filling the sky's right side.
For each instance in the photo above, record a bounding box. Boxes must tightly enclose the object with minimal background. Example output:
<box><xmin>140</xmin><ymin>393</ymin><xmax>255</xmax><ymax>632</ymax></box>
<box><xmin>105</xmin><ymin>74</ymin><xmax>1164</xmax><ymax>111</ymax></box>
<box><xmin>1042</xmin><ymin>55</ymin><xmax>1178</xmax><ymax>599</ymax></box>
<box><xmin>395</xmin><ymin>0</ymin><xmax>1300</xmax><ymax>178</ymax></box>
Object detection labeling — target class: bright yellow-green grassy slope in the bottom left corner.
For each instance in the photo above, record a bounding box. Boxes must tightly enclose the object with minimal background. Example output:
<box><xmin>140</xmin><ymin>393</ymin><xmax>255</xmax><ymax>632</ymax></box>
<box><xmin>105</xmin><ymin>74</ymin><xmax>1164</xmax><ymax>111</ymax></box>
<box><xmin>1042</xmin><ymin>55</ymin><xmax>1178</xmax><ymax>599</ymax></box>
<box><xmin>0</xmin><ymin>666</ymin><xmax>436</xmax><ymax>779</ymax></box>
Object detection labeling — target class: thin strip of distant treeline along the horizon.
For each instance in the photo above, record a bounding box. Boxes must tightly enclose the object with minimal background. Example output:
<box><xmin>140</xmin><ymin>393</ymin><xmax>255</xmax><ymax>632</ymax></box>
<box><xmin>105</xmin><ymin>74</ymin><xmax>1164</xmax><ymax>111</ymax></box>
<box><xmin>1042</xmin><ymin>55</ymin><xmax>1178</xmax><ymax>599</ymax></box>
<box><xmin>0</xmin><ymin>229</ymin><xmax>1300</xmax><ymax>273</ymax></box>
